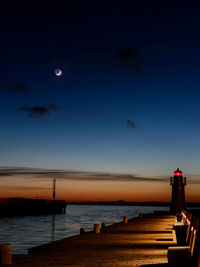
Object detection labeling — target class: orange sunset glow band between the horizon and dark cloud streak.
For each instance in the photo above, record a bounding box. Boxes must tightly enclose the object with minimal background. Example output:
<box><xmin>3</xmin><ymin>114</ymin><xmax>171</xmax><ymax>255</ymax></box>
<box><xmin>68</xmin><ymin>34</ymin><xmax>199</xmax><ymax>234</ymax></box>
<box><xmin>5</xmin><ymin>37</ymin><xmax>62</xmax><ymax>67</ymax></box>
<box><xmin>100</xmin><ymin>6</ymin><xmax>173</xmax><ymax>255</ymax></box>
<box><xmin>0</xmin><ymin>175</ymin><xmax>200</xmax><ymax>202</ymax></box>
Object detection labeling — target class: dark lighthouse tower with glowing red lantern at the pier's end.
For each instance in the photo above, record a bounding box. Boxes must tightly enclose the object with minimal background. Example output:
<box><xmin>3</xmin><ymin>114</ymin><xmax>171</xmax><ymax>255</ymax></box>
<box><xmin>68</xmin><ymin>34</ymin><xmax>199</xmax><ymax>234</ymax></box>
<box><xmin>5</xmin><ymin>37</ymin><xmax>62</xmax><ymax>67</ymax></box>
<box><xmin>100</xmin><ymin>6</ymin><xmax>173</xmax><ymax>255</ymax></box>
<box><xmin>170</xmin><ymin>168</ymin><xmax>186</xmax><ymax>213</ymax></box>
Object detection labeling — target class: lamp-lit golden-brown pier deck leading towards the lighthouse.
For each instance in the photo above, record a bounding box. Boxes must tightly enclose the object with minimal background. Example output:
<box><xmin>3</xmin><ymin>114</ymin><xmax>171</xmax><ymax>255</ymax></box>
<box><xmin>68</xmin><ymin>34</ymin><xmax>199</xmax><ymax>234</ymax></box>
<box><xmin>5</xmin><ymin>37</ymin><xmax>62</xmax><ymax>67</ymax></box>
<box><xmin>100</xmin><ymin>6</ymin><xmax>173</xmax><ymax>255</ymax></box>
<box><xmin>12</xmin><ymin>213</ymin><xmax>177</xmax><ymax>267</ymax></box>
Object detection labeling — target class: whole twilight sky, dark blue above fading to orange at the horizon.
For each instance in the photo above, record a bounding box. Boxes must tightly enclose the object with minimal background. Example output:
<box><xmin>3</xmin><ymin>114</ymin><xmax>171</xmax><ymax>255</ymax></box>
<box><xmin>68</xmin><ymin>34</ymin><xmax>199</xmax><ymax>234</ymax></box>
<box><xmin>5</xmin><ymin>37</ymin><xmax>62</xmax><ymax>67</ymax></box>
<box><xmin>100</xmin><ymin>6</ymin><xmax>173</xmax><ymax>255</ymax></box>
<box><xmin>0</xmin><ymin>0</ymin><xmax>200</xmax><ymax>201</ymax></box>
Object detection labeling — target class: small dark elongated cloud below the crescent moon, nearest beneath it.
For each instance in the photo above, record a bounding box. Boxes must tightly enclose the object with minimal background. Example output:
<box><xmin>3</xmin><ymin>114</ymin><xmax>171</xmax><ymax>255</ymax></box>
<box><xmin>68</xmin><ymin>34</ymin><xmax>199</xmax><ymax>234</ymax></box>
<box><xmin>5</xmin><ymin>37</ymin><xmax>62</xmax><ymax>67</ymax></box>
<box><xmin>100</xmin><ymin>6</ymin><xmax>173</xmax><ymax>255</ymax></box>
<box><xmin>20</xmin><ymin>105</ymin><xmax>59</xmax><ymax>118</ymax></box>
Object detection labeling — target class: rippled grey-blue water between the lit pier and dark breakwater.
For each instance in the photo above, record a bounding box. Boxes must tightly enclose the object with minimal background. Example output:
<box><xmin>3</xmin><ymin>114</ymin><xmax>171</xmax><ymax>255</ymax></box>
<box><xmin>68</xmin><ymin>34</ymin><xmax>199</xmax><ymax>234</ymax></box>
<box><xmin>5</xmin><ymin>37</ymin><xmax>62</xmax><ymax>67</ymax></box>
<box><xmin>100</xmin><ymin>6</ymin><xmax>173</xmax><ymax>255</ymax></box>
<box><xmin>0</xmin><ymin>205</ymin><xmax>168</xmax><ymax>254</ymax></box>
